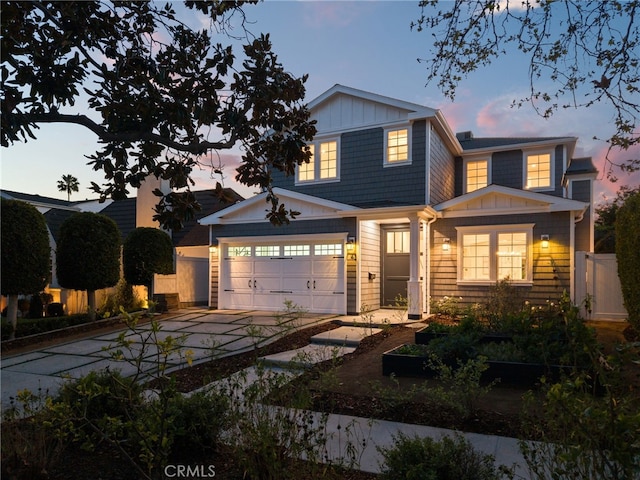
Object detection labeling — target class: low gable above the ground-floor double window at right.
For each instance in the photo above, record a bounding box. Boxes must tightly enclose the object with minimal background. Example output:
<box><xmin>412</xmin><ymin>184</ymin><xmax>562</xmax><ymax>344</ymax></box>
<box><xmin>434</xmin><ymin>184</ymin><xmax>589</xmax><ymax>218</ymax></box>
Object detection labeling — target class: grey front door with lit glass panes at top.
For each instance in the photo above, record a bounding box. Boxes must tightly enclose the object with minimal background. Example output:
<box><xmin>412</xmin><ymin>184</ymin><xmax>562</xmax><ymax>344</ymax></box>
<box><xmin>380</xmin><ymin>226</ymin><xmax>410</xmax><ymax>307</ymax></box>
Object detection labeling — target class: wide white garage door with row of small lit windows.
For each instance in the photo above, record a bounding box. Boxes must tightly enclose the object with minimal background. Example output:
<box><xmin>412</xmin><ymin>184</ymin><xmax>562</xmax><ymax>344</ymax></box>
<box><xmin>219</xmin><ymin>240</ymin><xmax>346</xmax><ymax>313</ymax></box>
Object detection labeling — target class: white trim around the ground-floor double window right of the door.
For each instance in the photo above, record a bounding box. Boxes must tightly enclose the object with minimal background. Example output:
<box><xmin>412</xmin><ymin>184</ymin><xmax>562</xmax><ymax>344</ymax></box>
<box><xmin>456</xmin><ymin>223</ymin><xmax>535</xmax><ymax>286</ymax></box>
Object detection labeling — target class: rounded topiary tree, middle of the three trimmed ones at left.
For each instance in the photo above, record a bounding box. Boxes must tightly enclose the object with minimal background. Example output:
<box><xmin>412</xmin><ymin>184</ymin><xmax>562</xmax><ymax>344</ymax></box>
<box><xmin>56</xmin><ymin>212</ymin><xmax>120</xmax><ymax>320</ymax></box>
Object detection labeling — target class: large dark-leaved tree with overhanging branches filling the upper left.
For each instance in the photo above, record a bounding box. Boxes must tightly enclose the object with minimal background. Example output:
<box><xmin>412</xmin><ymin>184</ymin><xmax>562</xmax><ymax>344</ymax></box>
<box><xmin>1</xmin><ymin>0</ymin><xmax>315</xmax><ymax>229</ymax></box>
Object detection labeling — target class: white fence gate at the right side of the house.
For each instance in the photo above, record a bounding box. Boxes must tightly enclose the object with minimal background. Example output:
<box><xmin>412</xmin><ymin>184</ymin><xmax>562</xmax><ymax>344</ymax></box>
<box><xmin>574</xmin><ymin>252</ymin><xmax>627</xmax><ymax>321</ymax></box>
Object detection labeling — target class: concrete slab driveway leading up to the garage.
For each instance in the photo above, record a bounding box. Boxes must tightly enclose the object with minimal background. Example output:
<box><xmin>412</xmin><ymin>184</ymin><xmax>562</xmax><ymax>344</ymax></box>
<box><xmin>1</xmin><ymin>308</ymin><xmax>337</xmax><ymax>409</ymax></box>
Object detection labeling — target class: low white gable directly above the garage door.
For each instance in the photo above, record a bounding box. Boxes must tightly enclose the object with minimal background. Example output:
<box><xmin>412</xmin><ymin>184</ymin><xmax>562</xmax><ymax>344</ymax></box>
<box><xmin>199</xmin><ymin>187</ymin><xmax>359</xmax><ymax>226</ymax></box>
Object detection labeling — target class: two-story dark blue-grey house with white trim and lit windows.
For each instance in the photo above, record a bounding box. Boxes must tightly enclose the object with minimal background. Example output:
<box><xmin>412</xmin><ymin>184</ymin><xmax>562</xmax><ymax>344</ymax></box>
<box><xmin>200</xmin><ymin>85</ymin><xmax>597</xmax><ymax>319</ymax></box>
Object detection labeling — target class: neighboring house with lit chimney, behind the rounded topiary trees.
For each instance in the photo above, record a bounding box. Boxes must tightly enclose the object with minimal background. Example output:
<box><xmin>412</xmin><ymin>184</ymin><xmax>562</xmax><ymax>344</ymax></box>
<box><xmin>0</xmin><ymin>182</ymin><xmax>243</xmax><ymax>313</ymax></box>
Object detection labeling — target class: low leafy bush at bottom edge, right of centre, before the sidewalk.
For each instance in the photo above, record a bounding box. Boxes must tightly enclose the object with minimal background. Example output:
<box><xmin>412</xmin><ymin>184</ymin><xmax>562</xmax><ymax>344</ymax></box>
<box><xmin>378</xmin><ymin>433</ymin><xmax>513</xmax><ymax>480</ymax></box>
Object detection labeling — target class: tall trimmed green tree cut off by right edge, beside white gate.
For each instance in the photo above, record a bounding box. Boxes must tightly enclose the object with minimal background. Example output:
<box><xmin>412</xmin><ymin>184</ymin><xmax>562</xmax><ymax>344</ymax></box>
<box><xmin>616</xmin><ymin>191</ymin><xmax>640</xmax><ymax>332</ymax></box>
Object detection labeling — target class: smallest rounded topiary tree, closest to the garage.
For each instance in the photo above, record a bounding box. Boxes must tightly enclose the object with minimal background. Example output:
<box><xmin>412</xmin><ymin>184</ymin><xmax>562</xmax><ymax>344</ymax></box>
<box><xmin>122</xmin><ymin>227</ymin><xmax>174</xmax><ymax>299</ymax></box>
